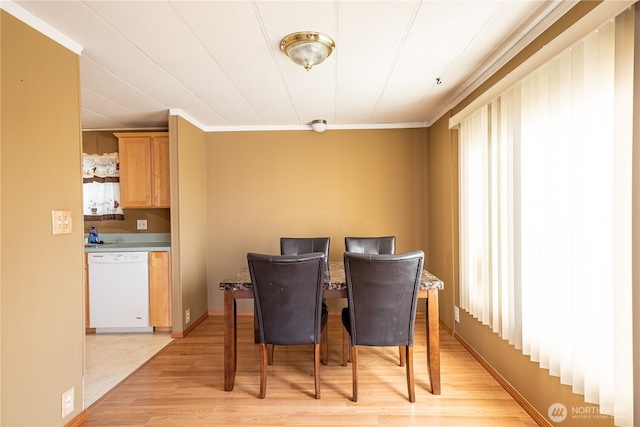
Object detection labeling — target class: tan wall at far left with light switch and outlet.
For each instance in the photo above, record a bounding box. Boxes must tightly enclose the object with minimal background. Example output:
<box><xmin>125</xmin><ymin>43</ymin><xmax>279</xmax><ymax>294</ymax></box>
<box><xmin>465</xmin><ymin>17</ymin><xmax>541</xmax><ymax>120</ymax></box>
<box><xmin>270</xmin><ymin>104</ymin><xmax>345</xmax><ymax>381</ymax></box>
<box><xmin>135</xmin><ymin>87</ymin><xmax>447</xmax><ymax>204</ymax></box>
<box><xmin>0</xmin><ymin>11</ymin><xmax>84</xmax><ymax>426</ymax></box>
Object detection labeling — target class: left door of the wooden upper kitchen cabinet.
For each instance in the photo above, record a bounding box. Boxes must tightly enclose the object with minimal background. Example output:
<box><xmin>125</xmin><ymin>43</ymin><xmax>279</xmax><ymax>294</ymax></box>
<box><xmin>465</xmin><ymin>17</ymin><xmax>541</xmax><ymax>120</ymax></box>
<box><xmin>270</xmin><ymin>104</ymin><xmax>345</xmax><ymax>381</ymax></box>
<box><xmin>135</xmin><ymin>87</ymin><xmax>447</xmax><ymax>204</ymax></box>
<box><xmin>118</xmin><ymin>136</ymin><xmax>152</xmax><ymax>208</ymax></box>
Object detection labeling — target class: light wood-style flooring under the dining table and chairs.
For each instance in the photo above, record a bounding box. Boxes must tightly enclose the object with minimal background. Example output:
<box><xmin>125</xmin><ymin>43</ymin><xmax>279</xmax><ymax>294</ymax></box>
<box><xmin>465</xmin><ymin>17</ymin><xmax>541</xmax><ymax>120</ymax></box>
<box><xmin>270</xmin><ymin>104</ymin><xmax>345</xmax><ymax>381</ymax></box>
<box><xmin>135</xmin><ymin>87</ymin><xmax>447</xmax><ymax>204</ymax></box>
<box><xmin>82</xmin><ymin>314</ymin><xmax>537</xmax><ymax>427</ymax></box>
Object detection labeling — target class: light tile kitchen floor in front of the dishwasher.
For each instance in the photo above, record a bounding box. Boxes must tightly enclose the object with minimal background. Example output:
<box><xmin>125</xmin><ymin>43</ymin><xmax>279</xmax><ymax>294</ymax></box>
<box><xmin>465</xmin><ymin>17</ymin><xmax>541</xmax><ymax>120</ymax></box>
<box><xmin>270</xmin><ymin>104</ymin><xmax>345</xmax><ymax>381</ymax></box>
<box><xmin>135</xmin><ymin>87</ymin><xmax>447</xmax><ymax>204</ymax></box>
<box><xmin>84</xmin><ymin>332</ymin><xmax>172</xmax><ymax>408</ymax></box>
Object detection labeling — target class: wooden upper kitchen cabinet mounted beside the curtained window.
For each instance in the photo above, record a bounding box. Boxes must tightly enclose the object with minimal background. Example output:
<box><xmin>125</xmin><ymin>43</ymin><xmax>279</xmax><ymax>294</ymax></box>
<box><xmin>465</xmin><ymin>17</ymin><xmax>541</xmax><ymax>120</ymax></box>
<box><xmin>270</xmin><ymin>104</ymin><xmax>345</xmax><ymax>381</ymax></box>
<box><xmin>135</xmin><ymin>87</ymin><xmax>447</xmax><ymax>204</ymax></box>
<box><xmin>114</xmin><ymin>132</ymin><xmax>171</xmax><ymax>209</ymax></box>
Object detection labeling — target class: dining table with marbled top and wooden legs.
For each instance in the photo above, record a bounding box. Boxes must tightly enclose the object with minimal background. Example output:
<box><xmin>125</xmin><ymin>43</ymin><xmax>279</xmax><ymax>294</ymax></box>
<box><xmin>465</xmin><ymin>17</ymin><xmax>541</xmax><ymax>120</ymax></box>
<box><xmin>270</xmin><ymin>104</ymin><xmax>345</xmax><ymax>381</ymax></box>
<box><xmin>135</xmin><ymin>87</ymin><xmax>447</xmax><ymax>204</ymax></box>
<box><xmin>220</xmin><ymin>261</ymin><xmax>444</xmax><ymax>394</ymax></box>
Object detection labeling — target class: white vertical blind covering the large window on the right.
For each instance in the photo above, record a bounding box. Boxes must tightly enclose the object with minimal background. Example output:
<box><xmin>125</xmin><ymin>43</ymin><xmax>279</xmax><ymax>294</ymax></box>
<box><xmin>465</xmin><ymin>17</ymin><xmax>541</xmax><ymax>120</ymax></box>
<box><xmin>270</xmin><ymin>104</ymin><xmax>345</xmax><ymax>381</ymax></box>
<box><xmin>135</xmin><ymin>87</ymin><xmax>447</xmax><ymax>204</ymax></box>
<box><xmin>459</xmin><ymin>12</ymin><xmax>633</xmax><ymax>427</ymax></box>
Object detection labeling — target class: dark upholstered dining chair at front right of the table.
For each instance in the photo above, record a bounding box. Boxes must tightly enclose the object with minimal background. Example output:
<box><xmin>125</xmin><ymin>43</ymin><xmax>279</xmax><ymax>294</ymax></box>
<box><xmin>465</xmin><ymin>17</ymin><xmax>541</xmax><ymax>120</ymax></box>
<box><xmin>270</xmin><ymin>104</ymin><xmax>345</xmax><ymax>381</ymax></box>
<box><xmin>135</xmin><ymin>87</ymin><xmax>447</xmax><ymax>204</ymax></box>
<box><xmin>342</xmin><ymin>251</ymin><xmax>424</xmax><ymax>402</ymax></box>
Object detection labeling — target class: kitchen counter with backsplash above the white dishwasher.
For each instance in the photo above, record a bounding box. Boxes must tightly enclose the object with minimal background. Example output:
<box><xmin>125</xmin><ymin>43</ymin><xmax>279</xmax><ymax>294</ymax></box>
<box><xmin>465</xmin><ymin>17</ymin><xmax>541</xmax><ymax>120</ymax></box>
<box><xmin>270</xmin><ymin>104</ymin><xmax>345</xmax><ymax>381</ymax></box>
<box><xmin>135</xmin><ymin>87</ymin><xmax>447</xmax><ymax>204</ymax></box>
<box><xmin>84</xmin><ymin>233</ymin><xmax>171</xmax><ymax>253</ymax></box>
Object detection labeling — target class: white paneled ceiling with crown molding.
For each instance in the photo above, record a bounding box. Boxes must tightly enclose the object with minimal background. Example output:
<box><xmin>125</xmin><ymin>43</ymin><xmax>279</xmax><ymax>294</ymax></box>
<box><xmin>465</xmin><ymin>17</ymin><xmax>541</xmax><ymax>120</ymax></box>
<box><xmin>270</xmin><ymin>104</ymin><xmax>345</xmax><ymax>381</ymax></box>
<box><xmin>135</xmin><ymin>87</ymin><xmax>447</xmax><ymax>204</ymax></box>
<box><xmin>1</xmin><ymin>0</ymin><xmax>577</xmax><ymax>131</ymax></box>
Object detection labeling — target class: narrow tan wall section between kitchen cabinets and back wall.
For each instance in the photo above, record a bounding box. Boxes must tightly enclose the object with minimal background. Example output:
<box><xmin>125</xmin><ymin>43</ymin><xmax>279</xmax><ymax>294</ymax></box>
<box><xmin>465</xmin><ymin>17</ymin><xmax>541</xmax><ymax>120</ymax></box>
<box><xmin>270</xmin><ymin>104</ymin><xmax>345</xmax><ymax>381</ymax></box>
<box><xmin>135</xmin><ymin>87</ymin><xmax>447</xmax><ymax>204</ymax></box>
<box><xmin>169</xmin><ymin>116</ymin><xmax>209</xmax><ymax>333</ymax></box>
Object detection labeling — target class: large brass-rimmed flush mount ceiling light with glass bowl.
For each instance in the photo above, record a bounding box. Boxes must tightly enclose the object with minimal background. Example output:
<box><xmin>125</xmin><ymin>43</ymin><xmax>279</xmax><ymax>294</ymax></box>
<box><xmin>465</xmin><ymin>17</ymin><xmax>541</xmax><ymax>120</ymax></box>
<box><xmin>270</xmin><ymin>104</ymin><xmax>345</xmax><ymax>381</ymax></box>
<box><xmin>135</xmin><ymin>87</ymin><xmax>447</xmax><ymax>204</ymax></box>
<box><xmin>280</xmin><ymin>31</ymin><xmax>336</xmax><ymax>71</ymax></box>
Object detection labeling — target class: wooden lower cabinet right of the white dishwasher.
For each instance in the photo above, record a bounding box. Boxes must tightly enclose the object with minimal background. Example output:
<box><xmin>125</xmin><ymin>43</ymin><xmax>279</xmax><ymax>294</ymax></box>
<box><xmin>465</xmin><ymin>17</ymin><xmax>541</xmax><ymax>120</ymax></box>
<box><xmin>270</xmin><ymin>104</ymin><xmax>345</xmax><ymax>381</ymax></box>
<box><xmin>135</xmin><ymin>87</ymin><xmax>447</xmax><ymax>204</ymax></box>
<box><xmin>149</xmin><ymin>251</ymin><xmax>171</xmax><ymax>330</ymax></box>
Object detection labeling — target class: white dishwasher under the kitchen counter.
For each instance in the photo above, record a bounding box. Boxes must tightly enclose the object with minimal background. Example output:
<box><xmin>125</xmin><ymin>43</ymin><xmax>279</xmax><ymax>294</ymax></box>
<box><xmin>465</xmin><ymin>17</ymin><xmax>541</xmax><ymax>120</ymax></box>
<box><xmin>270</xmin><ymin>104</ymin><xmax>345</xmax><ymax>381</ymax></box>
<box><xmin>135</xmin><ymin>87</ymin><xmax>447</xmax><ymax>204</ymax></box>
<box><xmin>87</xmin><ymin>252</ymin><xmax>153</xmax><ymax>333</ymax></box>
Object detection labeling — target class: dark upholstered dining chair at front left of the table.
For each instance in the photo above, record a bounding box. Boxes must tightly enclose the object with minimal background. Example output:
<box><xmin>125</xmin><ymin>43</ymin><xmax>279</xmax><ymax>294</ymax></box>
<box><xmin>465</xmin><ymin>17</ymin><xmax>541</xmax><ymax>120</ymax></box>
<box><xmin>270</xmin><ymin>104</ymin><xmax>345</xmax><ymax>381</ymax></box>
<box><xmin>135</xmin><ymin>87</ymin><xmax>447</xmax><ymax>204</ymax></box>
<box><xmin>247</xmin><ymin>252</ymin><xmax>327</xmax><ymax>399</ymax></box>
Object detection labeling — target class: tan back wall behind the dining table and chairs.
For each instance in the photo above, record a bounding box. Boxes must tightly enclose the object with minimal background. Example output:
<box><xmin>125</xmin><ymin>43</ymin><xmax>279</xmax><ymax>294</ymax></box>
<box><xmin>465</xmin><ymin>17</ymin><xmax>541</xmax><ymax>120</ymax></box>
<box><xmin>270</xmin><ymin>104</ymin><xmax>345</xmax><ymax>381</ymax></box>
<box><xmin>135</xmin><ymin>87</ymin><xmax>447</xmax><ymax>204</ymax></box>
<box><xmin>207</xmin><ymin>129</ymin><xmax>426</xmax><ymax>311</ymax></box>
